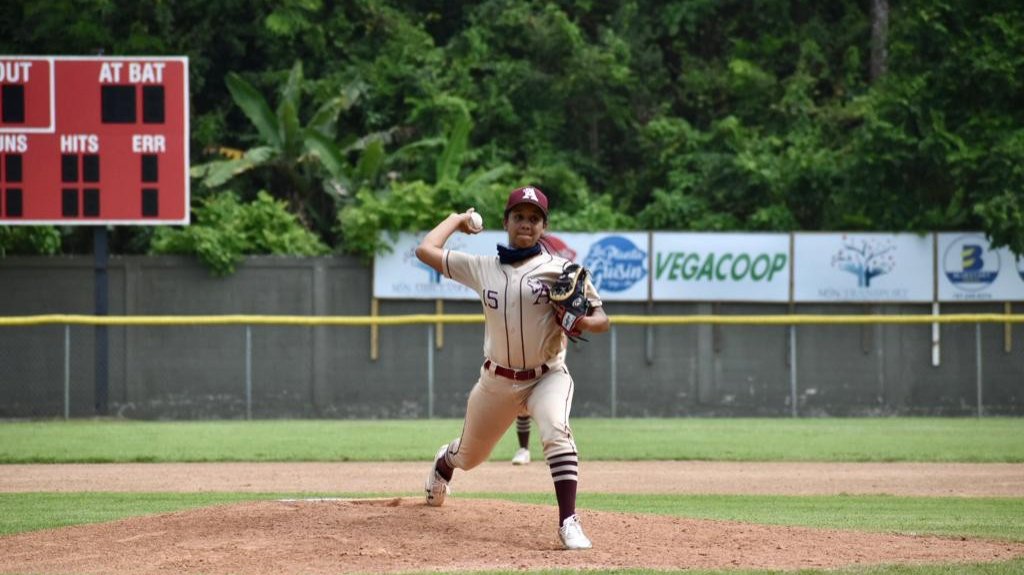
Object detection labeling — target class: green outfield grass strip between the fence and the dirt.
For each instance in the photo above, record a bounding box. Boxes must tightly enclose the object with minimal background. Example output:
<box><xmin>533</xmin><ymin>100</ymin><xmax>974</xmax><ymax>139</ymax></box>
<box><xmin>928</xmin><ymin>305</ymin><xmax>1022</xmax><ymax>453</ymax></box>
<box><xmin>0</xmin><ymin>417</ymin><xmax>1024</xmax><ymax>463</ymax></box>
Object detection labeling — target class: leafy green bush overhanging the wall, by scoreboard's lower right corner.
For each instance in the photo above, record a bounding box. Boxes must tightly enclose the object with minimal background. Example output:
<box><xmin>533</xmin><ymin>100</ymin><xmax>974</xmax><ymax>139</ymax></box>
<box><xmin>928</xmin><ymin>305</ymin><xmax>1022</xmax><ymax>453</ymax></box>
<box><xmin>151</xmin><ymin>191</ymin><xmax>330</xmax><ymax>275</ymax></box>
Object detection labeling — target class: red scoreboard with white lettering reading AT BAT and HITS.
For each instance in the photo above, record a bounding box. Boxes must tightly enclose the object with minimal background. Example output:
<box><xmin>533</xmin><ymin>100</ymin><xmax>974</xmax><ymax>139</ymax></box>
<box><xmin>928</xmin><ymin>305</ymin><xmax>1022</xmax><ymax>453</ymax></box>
<box><xmin>0</xmin><ymin>56</ymin><xmax>189</xmax><ymax>225</ymax></box>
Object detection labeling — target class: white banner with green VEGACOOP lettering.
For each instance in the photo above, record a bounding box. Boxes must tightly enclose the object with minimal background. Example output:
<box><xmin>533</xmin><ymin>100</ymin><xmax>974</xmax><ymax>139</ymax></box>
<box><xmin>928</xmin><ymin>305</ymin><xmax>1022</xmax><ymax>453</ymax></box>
<box><xmin>652</xmin><ymin>232</ymin><xmax>791</xmax><ymax>302</ymax></box>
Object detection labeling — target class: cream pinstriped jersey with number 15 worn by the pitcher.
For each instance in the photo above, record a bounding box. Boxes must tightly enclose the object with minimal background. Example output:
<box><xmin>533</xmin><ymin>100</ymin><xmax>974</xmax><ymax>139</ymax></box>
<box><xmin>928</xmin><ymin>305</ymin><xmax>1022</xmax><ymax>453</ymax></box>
<box><xmin>441</xmin><ymin>250</ymin><xmax>602</xmax><ymax>369</ymax></box>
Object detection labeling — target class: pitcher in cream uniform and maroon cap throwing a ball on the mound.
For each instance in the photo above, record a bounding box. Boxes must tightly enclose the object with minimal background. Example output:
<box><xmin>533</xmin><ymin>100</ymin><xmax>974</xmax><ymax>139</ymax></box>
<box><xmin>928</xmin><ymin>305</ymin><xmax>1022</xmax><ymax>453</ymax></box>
<box><xmin>416</xmin><ymin>186</ymin><xmax>609</xmax><ymax>549</ymax></box>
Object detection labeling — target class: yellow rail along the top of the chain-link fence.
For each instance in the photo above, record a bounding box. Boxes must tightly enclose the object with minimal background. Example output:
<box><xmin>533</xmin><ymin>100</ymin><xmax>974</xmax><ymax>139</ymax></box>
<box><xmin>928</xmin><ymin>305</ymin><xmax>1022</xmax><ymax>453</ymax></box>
<box><xmin>0</xmin><ymin>313</ymin><xmax>1024</xmax><ymax>327</ymax></box>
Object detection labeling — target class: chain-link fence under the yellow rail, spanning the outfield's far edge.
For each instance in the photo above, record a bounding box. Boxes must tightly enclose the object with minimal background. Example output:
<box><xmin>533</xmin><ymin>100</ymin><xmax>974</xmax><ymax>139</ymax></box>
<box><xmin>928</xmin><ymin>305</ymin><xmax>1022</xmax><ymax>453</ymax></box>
<box><xmin>0</xmin><ymin>315</ymin><xmax>1024</xmax><ymax>419</ymax></box>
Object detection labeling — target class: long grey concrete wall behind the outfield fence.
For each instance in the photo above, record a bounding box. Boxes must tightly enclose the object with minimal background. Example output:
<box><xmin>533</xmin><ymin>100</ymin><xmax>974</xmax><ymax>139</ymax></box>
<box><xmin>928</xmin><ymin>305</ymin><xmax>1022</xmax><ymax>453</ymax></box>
<box><xmin>0</xmin><ymin>257</ymin><xmax>1024</xmax><ymax>419</ymax></box>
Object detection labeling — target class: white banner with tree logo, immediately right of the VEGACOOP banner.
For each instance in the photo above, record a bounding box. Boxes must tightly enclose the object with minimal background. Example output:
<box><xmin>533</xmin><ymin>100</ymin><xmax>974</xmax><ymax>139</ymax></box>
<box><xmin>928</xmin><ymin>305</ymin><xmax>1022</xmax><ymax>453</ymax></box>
<box><xmin>793</xmin><ymin>232</ymin><xmax>935</xmax><ymax>302</ymax></box>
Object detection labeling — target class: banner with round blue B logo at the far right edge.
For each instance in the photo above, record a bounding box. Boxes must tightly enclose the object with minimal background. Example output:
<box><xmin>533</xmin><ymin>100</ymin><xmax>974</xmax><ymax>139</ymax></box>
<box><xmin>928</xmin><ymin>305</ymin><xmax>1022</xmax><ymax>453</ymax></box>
<box><xmin>938</xmin><ymin>232</ymin><xmax>1024</xmax><ymax>302</ymax></box>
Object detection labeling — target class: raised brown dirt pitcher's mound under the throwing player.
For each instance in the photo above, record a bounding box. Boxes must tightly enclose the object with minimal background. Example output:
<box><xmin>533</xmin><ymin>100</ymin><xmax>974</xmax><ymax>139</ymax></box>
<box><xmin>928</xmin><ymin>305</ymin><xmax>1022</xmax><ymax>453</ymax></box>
<box><xmin>0</xmin><ymin>498</ymin><xmax>1024</xmax><ymax>575</ymax></box>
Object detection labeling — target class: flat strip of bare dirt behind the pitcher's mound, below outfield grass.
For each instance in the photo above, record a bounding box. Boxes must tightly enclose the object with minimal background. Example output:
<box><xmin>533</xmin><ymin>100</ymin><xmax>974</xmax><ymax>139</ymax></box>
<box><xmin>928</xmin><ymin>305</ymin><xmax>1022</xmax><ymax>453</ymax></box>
<box><xmin>0</xmin><ymin>461</ymin><xmax>1024</xmax><ymax>497</ymax></box>
